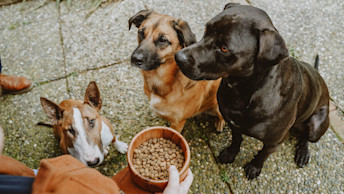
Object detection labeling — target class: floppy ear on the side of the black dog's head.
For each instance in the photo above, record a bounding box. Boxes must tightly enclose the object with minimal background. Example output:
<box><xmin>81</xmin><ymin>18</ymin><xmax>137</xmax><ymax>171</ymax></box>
<box><xmin>256</xmin><ymin>29</ymin><xmax>289</xmax><ymax>72</ymax></box>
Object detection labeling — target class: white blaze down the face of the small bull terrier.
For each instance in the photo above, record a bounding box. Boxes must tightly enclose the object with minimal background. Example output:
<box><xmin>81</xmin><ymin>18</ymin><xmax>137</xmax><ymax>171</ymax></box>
<box><xmin>68</xmin><ymin>108</ymin><xmax>104</xmax><ymax>165</ymax></box>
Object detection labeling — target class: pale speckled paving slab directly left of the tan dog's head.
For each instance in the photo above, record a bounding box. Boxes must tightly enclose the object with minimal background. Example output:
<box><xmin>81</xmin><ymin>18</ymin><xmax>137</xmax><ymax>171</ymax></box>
<box><xmin>61</xmin><ymin>2</ymin><xmax>137</xmax><ymax>72</ymax></box>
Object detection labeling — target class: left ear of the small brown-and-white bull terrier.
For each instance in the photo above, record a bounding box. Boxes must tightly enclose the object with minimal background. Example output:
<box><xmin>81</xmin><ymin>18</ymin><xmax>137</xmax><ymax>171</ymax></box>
<box><xmin>41</xmin><ymin>97</ymin><xmax>63</xmax><ymax>124</ymax></box>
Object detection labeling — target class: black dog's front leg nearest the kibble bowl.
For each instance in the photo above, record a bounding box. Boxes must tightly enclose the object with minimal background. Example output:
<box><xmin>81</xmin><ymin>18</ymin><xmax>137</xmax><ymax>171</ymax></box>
<box><xmin>218</xmin><ymin>129</ymin><xmax>243</xmax><ymax>163</ymax></box>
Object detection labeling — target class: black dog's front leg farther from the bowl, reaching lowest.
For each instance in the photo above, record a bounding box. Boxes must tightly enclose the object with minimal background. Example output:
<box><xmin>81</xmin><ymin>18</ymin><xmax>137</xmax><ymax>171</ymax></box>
<box><xmin>245</xmin><ymin>145</ymin><xmax>277</xmax><ymax>179</ymax></box>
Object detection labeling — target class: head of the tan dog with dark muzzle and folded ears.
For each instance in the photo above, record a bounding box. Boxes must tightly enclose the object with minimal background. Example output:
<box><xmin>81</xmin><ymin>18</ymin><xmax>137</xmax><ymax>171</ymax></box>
<box><xmin>129</xmin><ymin>10</ymin><xmax>196</xmax><ymax>71</ymax></box>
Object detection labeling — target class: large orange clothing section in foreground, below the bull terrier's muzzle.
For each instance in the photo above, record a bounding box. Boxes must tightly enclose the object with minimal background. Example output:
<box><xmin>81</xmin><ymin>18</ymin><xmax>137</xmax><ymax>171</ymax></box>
<box><xmin>32</xmin><ymin>155</ymin><xmax>120</xmax><ymax>194</ymax></box>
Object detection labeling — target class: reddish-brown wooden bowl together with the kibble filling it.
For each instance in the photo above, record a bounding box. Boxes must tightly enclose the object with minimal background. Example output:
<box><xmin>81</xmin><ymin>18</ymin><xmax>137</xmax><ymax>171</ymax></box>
<box><xmin>127</xmin><ymin>126</ymin><xmax>190</xmax><ymax>192</ymax></box>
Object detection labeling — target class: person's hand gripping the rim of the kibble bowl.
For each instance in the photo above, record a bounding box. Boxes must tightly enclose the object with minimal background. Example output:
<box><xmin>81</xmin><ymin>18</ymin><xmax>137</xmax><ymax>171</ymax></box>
<box><xmin>159</xmin><ymin>165</ymin><xmax>193</xmax><ymax>194</ymax></box>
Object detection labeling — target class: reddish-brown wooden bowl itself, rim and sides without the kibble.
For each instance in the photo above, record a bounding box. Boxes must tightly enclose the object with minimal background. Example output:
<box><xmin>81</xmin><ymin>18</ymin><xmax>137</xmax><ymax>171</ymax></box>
<box><xmin>127</xmin><ymin>126</ymin><xmax>191</xmax><ymax>192</ymax></box>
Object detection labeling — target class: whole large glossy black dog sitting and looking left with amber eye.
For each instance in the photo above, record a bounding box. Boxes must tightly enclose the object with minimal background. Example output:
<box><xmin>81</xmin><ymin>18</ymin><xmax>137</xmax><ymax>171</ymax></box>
<box><xmin>175</xmin><ymin>4</ymin><xmax>329</xmax><ymax>179</ymax></box>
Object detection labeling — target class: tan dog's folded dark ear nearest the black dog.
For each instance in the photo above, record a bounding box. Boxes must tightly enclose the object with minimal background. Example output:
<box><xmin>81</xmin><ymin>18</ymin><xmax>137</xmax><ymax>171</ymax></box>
<box><xmin>172</xmin><ymin>19</ymin><xmax>196</xmax><ymax>47</ymax></box>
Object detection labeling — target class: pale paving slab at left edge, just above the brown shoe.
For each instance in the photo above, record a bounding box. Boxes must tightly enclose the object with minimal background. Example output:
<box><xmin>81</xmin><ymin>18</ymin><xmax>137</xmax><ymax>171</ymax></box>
<box><xmin>0</xmin><ymin>19</ymin><xmax>65</xmax><ymax>83</ymax></box>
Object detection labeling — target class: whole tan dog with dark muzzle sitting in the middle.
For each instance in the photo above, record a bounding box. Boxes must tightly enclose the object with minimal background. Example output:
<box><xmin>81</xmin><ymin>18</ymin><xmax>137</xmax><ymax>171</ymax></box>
<box><xmin>129</xmin><ymin>10</ymin><xmax>225</xmax><ymax>132</ymax></box>
